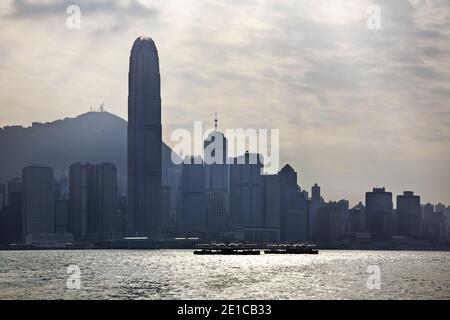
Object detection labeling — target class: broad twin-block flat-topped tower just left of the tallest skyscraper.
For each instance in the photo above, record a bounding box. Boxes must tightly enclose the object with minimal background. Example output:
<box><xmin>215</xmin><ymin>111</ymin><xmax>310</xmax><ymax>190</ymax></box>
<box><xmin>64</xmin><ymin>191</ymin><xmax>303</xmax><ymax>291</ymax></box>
<box><xmin>69</xmin><ymin>163</ymin><xmax>117</xmax><ymax>241</ymax></box>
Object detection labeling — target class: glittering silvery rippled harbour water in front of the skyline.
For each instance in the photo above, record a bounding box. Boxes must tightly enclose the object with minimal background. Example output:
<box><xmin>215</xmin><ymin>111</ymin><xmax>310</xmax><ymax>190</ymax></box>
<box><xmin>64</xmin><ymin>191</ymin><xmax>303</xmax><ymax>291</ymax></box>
<box><xmin>0</xmin><ymin>250</ymin><xmax>450</xmax><ymax>299</ymax></box>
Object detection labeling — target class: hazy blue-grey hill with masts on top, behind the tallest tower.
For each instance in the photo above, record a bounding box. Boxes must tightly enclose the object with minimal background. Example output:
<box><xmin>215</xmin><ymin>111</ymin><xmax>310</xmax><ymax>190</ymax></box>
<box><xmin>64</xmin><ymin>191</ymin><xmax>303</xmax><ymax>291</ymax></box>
<box><xmin>0</xmin><ymin>112</ymin><xmax>177</xmax><ymax>191</ymax></box>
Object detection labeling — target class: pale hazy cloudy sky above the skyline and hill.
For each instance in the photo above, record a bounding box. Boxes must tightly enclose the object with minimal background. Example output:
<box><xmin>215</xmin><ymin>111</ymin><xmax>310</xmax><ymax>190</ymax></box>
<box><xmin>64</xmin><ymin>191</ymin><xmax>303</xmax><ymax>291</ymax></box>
<box><xmin>0</xmin><ymin>0</ymin><xmax>450</xmax><ymax>204</ymax></box>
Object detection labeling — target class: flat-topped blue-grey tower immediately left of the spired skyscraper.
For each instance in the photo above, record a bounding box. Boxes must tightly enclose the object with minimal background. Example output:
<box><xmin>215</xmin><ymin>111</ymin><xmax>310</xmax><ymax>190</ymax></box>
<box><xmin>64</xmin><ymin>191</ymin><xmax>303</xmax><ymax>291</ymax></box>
<box><xmin>177</xmin><ymin>158</ymin><xmax>207</xmax><ymax>237</ymax></box>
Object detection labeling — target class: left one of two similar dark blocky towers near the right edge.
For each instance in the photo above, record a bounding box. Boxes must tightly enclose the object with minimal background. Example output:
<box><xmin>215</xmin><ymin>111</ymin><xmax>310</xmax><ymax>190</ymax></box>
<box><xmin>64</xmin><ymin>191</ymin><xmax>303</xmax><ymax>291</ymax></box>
<box><xmin>366</xmin><ymin>188</ymin><xmax>393</xmax><ymax>241</ymax></box>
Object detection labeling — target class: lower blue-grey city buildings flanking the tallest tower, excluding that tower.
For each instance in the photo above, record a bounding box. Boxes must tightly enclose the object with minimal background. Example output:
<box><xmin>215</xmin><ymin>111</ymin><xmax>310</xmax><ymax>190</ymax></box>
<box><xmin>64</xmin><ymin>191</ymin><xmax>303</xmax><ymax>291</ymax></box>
<box><xmin>0</xmin><ymin>162</ymin><xmax>450</xmax><ymax>248</ymax></box>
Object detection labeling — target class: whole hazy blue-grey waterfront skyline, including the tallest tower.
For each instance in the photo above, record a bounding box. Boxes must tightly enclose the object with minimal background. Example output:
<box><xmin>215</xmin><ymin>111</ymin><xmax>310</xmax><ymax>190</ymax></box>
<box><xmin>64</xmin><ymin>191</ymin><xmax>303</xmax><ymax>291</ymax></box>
<box><xmin>0</xmin><ymin>37</ymin><xmax>450</xmax><ymax>248</ymax></box>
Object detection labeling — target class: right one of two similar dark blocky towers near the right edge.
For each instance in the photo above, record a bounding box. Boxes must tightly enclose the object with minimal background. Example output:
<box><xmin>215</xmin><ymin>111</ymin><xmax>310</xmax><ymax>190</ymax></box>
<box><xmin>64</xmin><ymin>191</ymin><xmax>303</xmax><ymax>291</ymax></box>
<box><xmin>397</xmin><ymin>191</ymin><xmax>422</xmax><ymax>237</ymax></box>
